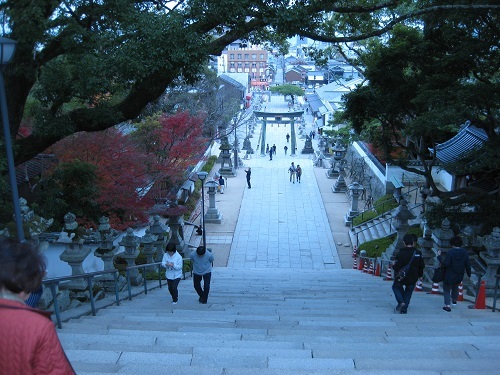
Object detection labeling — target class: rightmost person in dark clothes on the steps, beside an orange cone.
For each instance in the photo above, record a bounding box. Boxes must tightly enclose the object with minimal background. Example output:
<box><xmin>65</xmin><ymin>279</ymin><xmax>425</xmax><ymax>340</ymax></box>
<box><xmin>438</xmin><ymin>236</ymin><xmax>471</xmax><ymax>312</ymax></box>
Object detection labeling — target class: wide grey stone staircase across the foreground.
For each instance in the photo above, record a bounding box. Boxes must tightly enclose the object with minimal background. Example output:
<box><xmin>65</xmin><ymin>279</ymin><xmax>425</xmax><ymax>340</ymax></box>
<box><xmin>58</xmin><ymin>268</ymin><xmax>500</xmax><ymax>375</ymax></box>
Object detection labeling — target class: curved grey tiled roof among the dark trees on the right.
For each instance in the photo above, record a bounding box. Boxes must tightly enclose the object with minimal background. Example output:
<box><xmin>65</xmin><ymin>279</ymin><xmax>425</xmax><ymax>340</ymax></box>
<box><xmin>429</xmin><ymin>121</ymin><xmax>488</xmax><ymax>164</ymax></box>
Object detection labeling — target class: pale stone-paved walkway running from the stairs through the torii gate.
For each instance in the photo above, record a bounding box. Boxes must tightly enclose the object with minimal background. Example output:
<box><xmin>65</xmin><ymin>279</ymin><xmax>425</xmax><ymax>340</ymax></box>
<box><xmin>190</xmin><ymin>96</ymin><xmax>352</xmax><ymax>269</ymax></box>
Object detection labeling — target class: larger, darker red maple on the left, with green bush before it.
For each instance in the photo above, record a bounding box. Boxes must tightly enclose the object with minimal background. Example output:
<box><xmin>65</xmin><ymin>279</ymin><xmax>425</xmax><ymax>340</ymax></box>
<box><xmin>38</xmin><ymin>128</ymin><xmax>151</xmax><ymax>229</ymax></box>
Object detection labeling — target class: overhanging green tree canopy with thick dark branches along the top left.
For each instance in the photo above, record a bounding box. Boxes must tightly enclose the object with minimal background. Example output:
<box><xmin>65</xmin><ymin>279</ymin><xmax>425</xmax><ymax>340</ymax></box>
<box><xmin>0</xmin><ymin>0</ymin><xmax>496</xmax><ymax>164</ymax></box>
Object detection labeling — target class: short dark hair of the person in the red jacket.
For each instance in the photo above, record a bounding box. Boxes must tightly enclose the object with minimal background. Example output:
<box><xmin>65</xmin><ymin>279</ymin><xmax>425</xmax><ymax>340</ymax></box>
<box><xmin>0</xmin><ymin>238</ymin><xmax>47</xmax><ymax>293</ymax></box>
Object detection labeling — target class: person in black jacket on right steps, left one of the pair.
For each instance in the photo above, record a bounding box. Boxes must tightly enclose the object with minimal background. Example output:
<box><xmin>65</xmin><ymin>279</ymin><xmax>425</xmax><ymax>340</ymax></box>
<box><xmin>392</xmin><ymin>233</ymin><xmax>425</xmax><ymax>314</ymax></box>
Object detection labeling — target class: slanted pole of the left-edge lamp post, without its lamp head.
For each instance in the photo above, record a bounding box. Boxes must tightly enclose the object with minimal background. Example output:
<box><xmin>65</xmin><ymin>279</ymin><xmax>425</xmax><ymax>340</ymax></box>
<box><xmin>0</xmin><ymin>68</ymin><xmax>25</xmax><ymax>242</ymax></box>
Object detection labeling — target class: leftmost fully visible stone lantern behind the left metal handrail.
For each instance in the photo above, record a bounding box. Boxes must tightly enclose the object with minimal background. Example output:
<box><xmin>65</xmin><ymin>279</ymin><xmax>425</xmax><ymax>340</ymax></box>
<box><xmin>58</xmin><ymin>212</ymin><xmax>91</xmax><ymax>291</ymax></box>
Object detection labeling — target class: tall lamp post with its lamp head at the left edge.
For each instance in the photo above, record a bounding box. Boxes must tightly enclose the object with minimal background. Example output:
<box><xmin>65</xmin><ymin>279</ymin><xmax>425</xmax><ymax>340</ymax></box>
<box><xmin>0</xmin><ymin>38</ymin><xmax>25</xmax><ymax>242</ymax></box>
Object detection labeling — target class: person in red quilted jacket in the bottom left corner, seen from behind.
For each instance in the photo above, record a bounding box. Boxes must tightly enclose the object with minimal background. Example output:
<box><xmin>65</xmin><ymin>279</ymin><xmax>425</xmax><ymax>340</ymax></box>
<box><xmin>0</xmin><ymin>239</ymin><xmax>75</xmax><ymax>375</ymax></box>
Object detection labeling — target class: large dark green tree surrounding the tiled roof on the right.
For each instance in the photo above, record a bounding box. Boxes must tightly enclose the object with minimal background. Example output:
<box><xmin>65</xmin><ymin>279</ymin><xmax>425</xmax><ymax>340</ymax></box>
<box><xmin>338</xmin><ymin>12</ymin><xmax>500</xmax><ymax>234</ymax></box>
